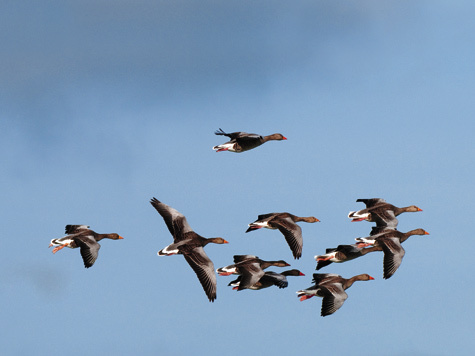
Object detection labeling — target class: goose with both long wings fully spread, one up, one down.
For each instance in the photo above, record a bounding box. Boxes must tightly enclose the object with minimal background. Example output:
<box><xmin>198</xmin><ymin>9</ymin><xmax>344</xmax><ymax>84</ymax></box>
<box><xmin>150</xmin><ymin>198</ymin><xmax>228</xmax><ymax>302</ymax></box>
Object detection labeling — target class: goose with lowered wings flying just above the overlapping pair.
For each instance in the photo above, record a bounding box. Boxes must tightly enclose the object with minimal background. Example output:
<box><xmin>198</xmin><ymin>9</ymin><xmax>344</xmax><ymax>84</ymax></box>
<box><xmin>246</xmin><ymin>213</ymin><xmax>320</xmax><ymax>259</ymax></box>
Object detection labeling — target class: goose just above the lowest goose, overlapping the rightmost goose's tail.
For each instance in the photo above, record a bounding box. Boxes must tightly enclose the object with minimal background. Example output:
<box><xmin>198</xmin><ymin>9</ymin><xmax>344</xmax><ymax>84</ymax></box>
<box><xmin>315</xmin><ymin>242</ymin><xmax>382</xmax><ymax>271</ymax></box>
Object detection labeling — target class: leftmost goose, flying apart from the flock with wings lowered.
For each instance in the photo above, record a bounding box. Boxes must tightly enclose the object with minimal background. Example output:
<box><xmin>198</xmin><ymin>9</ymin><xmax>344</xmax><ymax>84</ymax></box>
<box><xmin>49</xmin><ymin>225</ymin><xmax>123</xmax><ymax>268</ymax></box>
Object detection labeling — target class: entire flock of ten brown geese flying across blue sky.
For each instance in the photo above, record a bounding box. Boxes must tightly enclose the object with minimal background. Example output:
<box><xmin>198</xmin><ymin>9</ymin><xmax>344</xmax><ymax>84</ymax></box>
<box><xmin>49</xmin><ymin>129</ymin><xmax>428</xmax><ymax>316</ymax></box>
